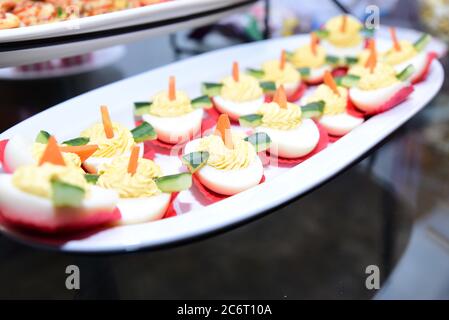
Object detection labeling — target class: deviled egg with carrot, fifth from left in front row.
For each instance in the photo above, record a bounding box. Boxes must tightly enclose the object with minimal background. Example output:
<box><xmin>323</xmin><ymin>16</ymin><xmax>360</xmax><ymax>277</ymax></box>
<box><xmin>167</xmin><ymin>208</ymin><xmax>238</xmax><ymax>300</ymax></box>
<box><xmin>304</xmin><ymin>71</ymin><xmax>363</xmax><ymax>137</ymax></box>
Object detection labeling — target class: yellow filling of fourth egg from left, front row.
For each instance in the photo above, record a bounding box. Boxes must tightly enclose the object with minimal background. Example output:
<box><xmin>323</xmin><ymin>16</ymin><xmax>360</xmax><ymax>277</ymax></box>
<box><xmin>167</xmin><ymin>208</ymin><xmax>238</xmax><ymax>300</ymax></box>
<box><xmin>257</xmin><ymin>102</ymin><xmax>301</xmax><ymax>130</ymax></box>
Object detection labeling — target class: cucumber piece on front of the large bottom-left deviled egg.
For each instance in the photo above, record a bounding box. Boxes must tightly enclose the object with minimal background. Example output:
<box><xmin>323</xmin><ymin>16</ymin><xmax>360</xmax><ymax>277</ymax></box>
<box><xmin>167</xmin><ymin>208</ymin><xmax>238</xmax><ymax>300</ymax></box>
<box><xmin>51</xmin><ymin>180</ymin><xmax>86</xmax><ymax>207</ymax></box>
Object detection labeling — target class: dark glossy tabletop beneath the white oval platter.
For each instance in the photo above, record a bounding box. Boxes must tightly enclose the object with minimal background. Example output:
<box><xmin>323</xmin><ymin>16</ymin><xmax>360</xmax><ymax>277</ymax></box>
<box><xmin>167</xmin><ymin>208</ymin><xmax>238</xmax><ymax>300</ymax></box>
<box><xmin>0</xmin><ymin>23</ymin><xmax>449</xmax><ymax>299</ymax></box>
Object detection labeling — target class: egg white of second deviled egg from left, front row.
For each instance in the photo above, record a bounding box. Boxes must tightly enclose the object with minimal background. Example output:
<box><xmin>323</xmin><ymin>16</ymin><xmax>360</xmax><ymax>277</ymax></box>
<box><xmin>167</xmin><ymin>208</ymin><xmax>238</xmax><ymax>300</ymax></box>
<box><xmin>117</xmin><ymin>193</ymin><xmax>171</xmax><ymax>224</ymax></box>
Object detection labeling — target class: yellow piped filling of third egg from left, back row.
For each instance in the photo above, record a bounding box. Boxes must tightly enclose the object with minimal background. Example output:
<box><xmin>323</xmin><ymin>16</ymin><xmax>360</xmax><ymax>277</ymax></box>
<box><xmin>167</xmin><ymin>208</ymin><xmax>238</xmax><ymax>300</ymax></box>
<box><xmin>150</xmin><ymin>91</ymin><xmax>193</xmax><ymax>117</ymax></box>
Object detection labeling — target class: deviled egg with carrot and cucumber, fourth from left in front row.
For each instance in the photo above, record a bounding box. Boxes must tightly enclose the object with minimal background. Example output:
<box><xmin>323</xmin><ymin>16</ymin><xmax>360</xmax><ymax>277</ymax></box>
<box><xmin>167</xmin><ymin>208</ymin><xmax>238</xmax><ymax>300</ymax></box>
<box><xmin>239</xmin><ymin>86</ymin><xmax>324</xmax><ymax>158</ymax></box>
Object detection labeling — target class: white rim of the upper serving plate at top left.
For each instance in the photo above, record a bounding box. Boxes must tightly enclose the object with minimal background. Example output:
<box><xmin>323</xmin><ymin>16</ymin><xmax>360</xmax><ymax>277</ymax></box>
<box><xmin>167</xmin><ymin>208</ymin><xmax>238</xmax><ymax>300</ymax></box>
<box><xmin>0</xmin><ymin>0</ymin><xmax>256</xmax><ymax>67</ymax></box>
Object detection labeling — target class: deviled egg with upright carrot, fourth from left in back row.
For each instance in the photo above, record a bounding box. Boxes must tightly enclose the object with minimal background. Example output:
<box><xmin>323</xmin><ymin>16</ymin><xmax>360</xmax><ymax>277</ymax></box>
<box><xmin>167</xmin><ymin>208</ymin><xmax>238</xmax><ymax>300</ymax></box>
<box><xmin>202</xmin><ymin>62</ymin><xmax>276</xmax><ymax>120</ymax></box>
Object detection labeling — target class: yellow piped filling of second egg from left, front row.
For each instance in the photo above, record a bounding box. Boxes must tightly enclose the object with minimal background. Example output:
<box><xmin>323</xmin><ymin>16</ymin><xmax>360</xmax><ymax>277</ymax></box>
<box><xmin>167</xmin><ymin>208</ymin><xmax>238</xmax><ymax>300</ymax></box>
<box><xmin>97</xmin><ymin>156</ymin><xmax>162</xmax><ymax>198</ymax></box>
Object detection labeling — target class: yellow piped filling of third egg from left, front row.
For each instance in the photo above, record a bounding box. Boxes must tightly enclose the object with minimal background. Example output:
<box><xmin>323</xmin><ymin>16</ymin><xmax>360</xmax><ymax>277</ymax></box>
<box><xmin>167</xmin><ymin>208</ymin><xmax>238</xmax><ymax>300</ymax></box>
<box><xmin>196</xmin><ymin>133</ymin><xmax>256</xmax><ymax>170</ymax></box>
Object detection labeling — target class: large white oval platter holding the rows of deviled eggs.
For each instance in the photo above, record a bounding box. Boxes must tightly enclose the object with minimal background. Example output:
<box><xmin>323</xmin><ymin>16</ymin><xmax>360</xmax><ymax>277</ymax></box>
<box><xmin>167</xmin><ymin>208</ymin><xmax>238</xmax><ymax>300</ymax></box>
<box><xmin>0</xmin><ymin>30</ymin><xmax>444</xmax><ymax>253</ymax></box>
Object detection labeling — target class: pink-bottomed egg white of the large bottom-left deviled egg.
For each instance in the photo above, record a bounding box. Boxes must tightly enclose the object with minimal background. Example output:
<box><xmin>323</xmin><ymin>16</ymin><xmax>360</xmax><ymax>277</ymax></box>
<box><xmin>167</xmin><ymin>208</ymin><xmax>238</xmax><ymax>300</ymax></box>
<box><xmin>0</xmin><ymin>174</ymin><xmax>118</xmax><ymax>228</ymax></box>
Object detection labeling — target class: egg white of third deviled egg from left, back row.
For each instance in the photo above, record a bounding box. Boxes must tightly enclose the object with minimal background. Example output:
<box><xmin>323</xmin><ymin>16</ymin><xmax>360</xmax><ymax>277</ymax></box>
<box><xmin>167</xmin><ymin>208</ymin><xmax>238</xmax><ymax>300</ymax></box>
<box><xmin>142</xmin><ymin>109</ymin><xmax>204</xmax><ymax>144</ymax></box>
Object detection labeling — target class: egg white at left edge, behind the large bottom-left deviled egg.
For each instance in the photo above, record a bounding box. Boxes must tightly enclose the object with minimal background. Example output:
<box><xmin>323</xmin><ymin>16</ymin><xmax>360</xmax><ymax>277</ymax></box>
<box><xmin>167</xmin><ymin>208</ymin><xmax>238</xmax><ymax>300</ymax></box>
<box><xmin>3</xmin><ymin>135</ymin><xmax>36</xmax><ymax>172</ymax></box>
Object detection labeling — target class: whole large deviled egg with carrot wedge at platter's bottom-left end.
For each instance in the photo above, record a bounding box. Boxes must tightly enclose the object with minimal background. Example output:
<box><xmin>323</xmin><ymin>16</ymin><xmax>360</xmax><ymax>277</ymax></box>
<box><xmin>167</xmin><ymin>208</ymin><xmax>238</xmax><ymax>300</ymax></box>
<box><xmin>0</xmin><ymin>137</ymin><xmax>120</xmax><ymax>232</ymax></box>
